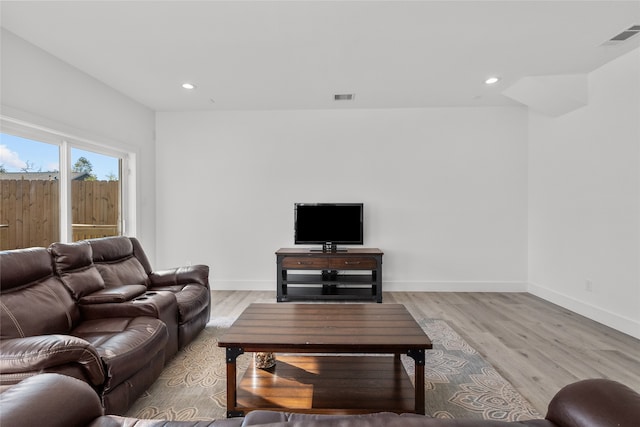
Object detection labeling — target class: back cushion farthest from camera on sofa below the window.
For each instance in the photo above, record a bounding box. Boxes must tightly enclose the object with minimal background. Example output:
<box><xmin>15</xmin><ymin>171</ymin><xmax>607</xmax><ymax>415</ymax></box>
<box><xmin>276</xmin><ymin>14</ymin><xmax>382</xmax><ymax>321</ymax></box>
<box><xmin>88</xmin><ymin>236</ymin><xmax>149</xmax><ymax>287</ymax></box>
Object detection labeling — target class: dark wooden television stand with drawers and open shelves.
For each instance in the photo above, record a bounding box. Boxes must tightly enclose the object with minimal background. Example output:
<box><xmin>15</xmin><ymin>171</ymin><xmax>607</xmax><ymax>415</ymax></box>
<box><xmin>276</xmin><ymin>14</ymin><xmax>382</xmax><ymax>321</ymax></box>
<box><xmin>276</xmin><ymin>248</ymin><xmax>383</xmax><ymax>303</ymax></box>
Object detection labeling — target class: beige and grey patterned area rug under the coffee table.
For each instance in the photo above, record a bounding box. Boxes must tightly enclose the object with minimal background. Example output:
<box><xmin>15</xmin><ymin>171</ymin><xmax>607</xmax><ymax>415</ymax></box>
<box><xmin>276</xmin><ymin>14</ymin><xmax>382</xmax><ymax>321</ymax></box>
<box><xmin>126</xmin><ymin>318</ymin><xmax>542</xmax><ymax>421</ymax></box>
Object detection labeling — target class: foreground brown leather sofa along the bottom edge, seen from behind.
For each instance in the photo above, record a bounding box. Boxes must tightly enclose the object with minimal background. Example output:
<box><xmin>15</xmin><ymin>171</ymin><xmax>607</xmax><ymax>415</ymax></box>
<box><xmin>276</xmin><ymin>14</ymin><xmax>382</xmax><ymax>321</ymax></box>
<box><xmin>0</xmin><ymin>374</ymin><xmax>640</xmax><ymax>427</ymax></box>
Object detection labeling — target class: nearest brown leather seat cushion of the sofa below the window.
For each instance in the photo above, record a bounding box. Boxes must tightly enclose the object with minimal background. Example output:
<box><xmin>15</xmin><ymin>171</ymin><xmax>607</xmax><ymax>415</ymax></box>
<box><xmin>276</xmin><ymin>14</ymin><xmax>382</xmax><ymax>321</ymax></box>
<box><xmin>72</xmin><ymin>316</ymin><xmax>168</xmax><ymax>391</ymax></box>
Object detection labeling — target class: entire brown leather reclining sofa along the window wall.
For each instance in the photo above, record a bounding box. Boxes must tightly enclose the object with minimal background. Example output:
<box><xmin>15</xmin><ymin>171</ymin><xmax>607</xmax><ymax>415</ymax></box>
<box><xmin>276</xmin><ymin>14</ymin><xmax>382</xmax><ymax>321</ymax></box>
<box><xmin>0</xmin><ymin>236</ymin><xmax>211</xmax><ymax>414</ymax></box>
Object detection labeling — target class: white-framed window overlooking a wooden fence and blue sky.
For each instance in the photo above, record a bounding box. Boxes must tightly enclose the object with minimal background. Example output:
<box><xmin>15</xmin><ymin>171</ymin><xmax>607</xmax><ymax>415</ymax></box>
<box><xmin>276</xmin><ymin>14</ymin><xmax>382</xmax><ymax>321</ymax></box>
<box><xmin>0</xmin><ymin>121</ymin><xmax>133</xmax><ymax>250</ymax></box>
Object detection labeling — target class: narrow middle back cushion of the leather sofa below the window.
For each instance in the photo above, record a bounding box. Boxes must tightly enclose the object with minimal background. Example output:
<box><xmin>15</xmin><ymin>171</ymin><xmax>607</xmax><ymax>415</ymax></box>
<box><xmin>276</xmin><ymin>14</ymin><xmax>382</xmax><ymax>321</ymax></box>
<box><xmin>49</xmin><ymin>241</ymin><xmax>105</xmax><ymax>301</ymax></box>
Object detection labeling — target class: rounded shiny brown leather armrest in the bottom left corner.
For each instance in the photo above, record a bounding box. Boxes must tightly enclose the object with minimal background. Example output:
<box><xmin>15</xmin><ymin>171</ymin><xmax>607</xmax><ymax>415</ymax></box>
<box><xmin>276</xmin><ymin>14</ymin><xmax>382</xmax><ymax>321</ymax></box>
<box><xmin>0</xmin><ymin>374</ymin><xmax>103</xmax><ymax>427</ymax></box>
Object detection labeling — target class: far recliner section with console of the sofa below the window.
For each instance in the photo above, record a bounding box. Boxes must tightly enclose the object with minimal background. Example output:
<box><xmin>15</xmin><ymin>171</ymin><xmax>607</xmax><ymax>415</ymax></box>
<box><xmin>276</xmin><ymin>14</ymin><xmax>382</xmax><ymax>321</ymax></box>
<box><xmin>49</xmin><ymin>236</ymin><xmax>211</xmax><ymax>359</ymax></box>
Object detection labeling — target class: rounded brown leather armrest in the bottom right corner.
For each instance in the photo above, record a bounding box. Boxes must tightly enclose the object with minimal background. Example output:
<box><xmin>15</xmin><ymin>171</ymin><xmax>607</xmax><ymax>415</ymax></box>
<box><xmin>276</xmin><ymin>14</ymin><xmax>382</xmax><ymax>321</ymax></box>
<box><xmin>546</xmin><ymin>379</ymin><xmax>640</xmax><ymax>427</ymax></box>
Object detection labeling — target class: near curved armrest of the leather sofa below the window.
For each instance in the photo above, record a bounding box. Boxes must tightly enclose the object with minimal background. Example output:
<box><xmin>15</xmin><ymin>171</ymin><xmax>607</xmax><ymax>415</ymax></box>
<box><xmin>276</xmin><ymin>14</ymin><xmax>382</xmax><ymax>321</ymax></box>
<box><xmin>0</xmin><ymin>335</ymin><xmax>105</xmax><ymax>385</ymax></box>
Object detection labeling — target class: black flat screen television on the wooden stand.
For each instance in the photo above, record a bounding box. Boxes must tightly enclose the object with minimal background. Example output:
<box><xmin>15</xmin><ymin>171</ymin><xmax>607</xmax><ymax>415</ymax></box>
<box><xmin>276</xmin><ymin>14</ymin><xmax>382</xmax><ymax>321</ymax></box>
<box><xmin>294</xmin><ymin>203</ymin><xmax>364</xmax><ymax>251</ymax></box>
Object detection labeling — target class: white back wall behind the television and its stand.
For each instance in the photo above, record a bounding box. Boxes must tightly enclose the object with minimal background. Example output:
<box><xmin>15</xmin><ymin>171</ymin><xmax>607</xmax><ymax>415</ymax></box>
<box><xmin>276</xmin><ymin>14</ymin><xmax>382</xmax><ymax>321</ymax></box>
<box><xmin>156</xmin><ymin>108</ymin><xmax>527</xmax><ymax>290</ymax></box>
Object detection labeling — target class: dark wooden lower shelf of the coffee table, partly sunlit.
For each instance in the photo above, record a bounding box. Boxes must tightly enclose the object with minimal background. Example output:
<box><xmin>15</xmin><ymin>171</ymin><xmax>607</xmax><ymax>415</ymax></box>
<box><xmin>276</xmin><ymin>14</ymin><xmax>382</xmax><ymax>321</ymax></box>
<box><xmin>236</xmin><ymin>355</ymin><xmax>415</xmax><ymax>414</ymax></box>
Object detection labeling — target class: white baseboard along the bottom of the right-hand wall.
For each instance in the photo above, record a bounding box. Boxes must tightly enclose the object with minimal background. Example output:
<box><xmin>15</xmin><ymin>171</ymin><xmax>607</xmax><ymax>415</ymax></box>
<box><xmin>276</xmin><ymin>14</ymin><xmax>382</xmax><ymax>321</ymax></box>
<box><xmin>528</xmin><ymin>283</ymin><xmax>640</xmax><ymax>339</ymax></box>
